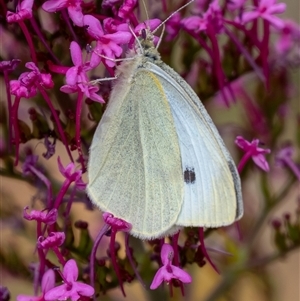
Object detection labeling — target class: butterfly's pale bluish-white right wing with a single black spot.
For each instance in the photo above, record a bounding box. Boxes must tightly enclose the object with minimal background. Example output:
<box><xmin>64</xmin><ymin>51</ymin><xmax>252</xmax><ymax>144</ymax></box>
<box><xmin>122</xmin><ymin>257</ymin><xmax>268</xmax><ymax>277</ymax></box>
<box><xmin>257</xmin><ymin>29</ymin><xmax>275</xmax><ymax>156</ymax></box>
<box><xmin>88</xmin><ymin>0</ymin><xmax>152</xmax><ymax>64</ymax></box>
<box><xmin>146</xmin><ymin>62</ymin><xmax>243</xmax><ymax>227</ymax></box>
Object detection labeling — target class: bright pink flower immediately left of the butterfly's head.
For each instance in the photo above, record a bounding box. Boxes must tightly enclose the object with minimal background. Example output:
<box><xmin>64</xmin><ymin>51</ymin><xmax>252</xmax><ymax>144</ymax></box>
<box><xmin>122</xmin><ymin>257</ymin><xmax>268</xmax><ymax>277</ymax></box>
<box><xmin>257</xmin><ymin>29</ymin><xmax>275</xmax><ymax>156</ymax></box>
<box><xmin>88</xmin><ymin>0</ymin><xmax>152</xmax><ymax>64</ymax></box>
<box><xmin>83</xmin><ymin>15</ymin><xmax>132</xmax><ymax>68</ymax></box>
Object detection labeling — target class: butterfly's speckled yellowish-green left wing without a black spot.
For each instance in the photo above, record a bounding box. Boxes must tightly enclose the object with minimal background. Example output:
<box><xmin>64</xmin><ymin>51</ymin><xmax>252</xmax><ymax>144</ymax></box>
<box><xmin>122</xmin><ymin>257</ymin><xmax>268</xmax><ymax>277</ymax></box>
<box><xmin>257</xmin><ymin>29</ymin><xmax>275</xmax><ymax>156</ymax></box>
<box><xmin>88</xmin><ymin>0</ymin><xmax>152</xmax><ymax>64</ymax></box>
<box><xmin>87</xmin><ymin>69</ymin><xmax>184</xmax><ymax>239</ymax></box>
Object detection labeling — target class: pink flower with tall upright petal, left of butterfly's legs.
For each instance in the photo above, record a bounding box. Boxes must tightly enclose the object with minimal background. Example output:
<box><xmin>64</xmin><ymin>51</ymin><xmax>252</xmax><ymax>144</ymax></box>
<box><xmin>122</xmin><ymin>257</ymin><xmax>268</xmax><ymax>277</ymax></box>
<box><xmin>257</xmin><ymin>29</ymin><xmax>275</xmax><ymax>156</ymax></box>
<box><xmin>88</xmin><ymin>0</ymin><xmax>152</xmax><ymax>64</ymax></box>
<box><xmin>60</xmin><ymin>41</ymin><xmax>104</xmax><ymax>103</ymax></box>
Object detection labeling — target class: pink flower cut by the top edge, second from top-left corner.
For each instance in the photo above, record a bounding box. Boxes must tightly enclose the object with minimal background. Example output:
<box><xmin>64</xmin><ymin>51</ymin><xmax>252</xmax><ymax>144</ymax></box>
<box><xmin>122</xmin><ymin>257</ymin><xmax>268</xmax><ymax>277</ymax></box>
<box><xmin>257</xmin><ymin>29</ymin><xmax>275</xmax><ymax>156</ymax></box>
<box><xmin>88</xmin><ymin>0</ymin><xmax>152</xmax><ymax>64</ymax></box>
<box><xmin>42</xmin><ymin>0</ymin><xmax>83</xmax><ymax>27</ymax></box>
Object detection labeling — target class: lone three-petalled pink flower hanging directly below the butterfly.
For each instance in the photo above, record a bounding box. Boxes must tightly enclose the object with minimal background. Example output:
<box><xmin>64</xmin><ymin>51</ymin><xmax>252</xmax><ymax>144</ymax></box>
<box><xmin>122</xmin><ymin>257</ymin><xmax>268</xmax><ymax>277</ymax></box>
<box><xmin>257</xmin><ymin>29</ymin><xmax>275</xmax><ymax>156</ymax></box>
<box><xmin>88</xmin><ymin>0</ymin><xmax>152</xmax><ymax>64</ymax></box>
<box><xmin>150</xmin><ymin>244</ymin><xmax>192</xmax><ymax>290</ymax></box>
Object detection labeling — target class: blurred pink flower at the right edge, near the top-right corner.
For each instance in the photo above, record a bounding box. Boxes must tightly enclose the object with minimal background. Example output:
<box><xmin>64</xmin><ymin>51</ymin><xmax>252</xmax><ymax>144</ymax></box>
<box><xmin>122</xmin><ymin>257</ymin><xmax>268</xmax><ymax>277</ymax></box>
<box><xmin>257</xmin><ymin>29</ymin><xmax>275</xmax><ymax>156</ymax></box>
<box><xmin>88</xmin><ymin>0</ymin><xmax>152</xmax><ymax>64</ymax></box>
<box><xmin>275</xmin><ymin>20</ymin><xmax>300</xmax><ymax>54</ymax></box>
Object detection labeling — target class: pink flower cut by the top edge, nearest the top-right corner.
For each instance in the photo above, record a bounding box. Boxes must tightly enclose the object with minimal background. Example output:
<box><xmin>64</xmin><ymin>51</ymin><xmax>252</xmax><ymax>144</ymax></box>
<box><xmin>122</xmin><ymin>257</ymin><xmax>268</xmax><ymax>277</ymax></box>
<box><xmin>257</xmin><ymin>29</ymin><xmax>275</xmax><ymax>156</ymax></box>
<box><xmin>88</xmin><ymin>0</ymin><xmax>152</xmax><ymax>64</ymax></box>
<box><xmin>241</xmin><ymin>0</ymin><xmax>286</xmax><ymax>28</ymax></box>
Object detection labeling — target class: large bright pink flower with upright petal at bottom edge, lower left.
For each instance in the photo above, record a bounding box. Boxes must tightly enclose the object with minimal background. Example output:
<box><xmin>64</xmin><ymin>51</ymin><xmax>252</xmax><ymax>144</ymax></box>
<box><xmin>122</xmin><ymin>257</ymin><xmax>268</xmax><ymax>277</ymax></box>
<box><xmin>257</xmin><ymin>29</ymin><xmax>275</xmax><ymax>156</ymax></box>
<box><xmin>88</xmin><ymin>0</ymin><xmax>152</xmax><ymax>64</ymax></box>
<box><xmin>44</xmin><ymin>259</ymin><xmax>95</xmax><ymax>301</ymax></box>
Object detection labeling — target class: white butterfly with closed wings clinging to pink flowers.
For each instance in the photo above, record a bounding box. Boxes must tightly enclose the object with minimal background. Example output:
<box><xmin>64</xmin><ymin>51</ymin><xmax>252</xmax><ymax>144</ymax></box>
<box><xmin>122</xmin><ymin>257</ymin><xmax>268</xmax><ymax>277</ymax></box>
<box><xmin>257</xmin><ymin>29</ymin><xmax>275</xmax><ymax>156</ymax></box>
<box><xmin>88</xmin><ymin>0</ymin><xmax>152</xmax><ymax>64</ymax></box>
<box><xmin>87</xmin><ymin>27</ymin><xmax>243</xmax><ymax>239</ymax></box>
